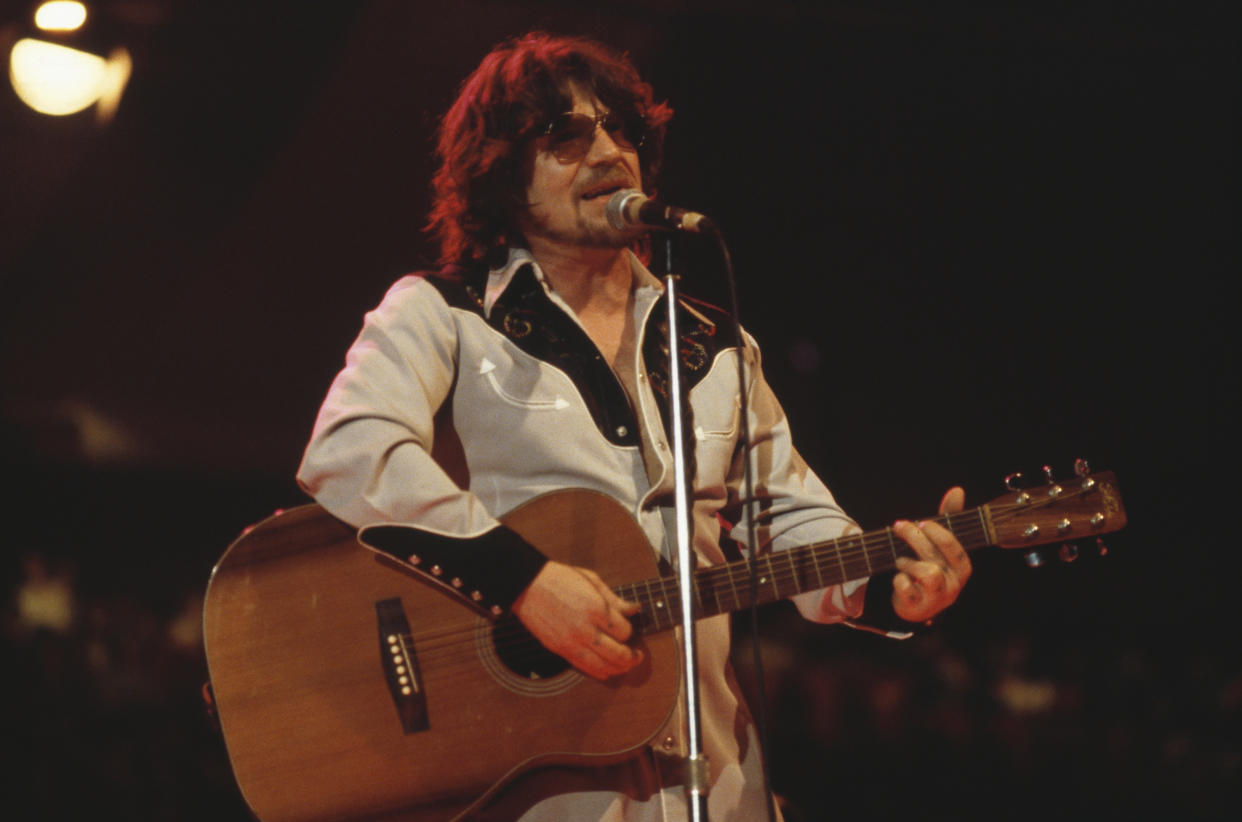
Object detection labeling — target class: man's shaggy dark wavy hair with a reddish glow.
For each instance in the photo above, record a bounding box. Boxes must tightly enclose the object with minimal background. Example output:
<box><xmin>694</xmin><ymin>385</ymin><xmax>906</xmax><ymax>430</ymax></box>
<box><xmin>426</xmin><ymin>31</ymin><xmax>673</xmax><ymax>266</ymax></box>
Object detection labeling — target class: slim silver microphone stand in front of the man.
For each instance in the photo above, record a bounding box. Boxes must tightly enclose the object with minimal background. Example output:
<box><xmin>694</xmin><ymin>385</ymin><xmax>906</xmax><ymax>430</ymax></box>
<box><xmin>664</xmin><ymin>237</ymin><xmax>708</xmax><ymax>822</ymax></box>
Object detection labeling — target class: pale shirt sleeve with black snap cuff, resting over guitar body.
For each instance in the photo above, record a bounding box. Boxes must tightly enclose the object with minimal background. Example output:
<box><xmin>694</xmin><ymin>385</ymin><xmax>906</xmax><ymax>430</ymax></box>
<box><xmin>297</xmin><ymin>277</ymin><xmax>545</xmax><ymax>610</ymax></box>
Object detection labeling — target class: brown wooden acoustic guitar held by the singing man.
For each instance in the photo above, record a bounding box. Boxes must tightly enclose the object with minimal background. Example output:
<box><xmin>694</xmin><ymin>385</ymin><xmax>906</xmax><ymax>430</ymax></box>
<box><xmin>204</xmin><ymin>472</ymin><xmax>1125</xmax><ymax>822</ymax></box>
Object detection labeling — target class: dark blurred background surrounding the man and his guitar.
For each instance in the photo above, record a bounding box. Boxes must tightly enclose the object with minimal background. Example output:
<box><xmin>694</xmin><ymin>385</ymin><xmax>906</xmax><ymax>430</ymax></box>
<box><xmin>0</xmin><ymin>0</ymin><xmax>1242</xmax><ymax>820</ymax></box>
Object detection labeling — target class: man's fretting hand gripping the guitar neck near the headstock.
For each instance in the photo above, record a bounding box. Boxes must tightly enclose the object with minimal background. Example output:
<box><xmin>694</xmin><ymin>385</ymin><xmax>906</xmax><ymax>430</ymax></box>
<box><xmin>893</xmin><ymin>488</ymin><xmax>970</xmax><ymax>622</ymax></box>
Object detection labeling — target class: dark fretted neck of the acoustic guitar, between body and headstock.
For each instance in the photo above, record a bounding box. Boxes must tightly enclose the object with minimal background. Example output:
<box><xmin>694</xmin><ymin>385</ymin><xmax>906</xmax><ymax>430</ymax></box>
<box><xmin>616</xmin><ymin>505</ymin><xmax>994</xmax><ymax>633</ymax></box>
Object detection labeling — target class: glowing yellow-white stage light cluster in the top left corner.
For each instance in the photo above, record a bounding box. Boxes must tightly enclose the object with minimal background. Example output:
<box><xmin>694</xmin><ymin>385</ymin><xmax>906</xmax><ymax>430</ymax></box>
<box><xmin>9</xmin><ymin>0</ymin><xmax>133</xmax><ymax>122</ymax></box>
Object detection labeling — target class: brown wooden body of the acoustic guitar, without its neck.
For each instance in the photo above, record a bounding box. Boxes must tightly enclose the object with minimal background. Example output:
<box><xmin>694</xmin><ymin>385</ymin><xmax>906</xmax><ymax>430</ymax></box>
<box><xmin>204</xmin><ymin>490</ymin><xmax>681</xmax><ymax>822</ymax></box>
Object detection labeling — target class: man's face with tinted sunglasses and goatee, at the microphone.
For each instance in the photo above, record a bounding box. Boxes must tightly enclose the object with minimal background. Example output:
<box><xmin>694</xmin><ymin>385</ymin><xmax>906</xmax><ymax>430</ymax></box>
<box><xmin>520</xmin><ymin>88</ymin><xmax>642</xmax><ymax>251</ymax></box>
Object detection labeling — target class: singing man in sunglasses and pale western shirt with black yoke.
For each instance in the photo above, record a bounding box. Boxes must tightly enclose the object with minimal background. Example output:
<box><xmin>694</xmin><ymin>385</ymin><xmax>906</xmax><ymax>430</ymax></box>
<box><xmin>298</xmin><ymin>34</ymin><xmax>970</xmax><ymax>822</ymax></box>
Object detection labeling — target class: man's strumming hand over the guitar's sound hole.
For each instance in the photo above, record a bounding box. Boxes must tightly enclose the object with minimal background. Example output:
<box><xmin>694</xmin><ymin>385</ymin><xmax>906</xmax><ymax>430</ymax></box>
<box><xmin>513</xmin><ymin>561</ymin><xmax>642</xmax><ymax>679</ymax></box>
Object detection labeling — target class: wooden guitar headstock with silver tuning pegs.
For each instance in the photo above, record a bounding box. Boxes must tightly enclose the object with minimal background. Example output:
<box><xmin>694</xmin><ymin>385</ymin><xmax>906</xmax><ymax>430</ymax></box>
<box><xmin>987</xmin><ymin>461</ymin><xmax>1125</xmax><ymax>564</ymax></box>
